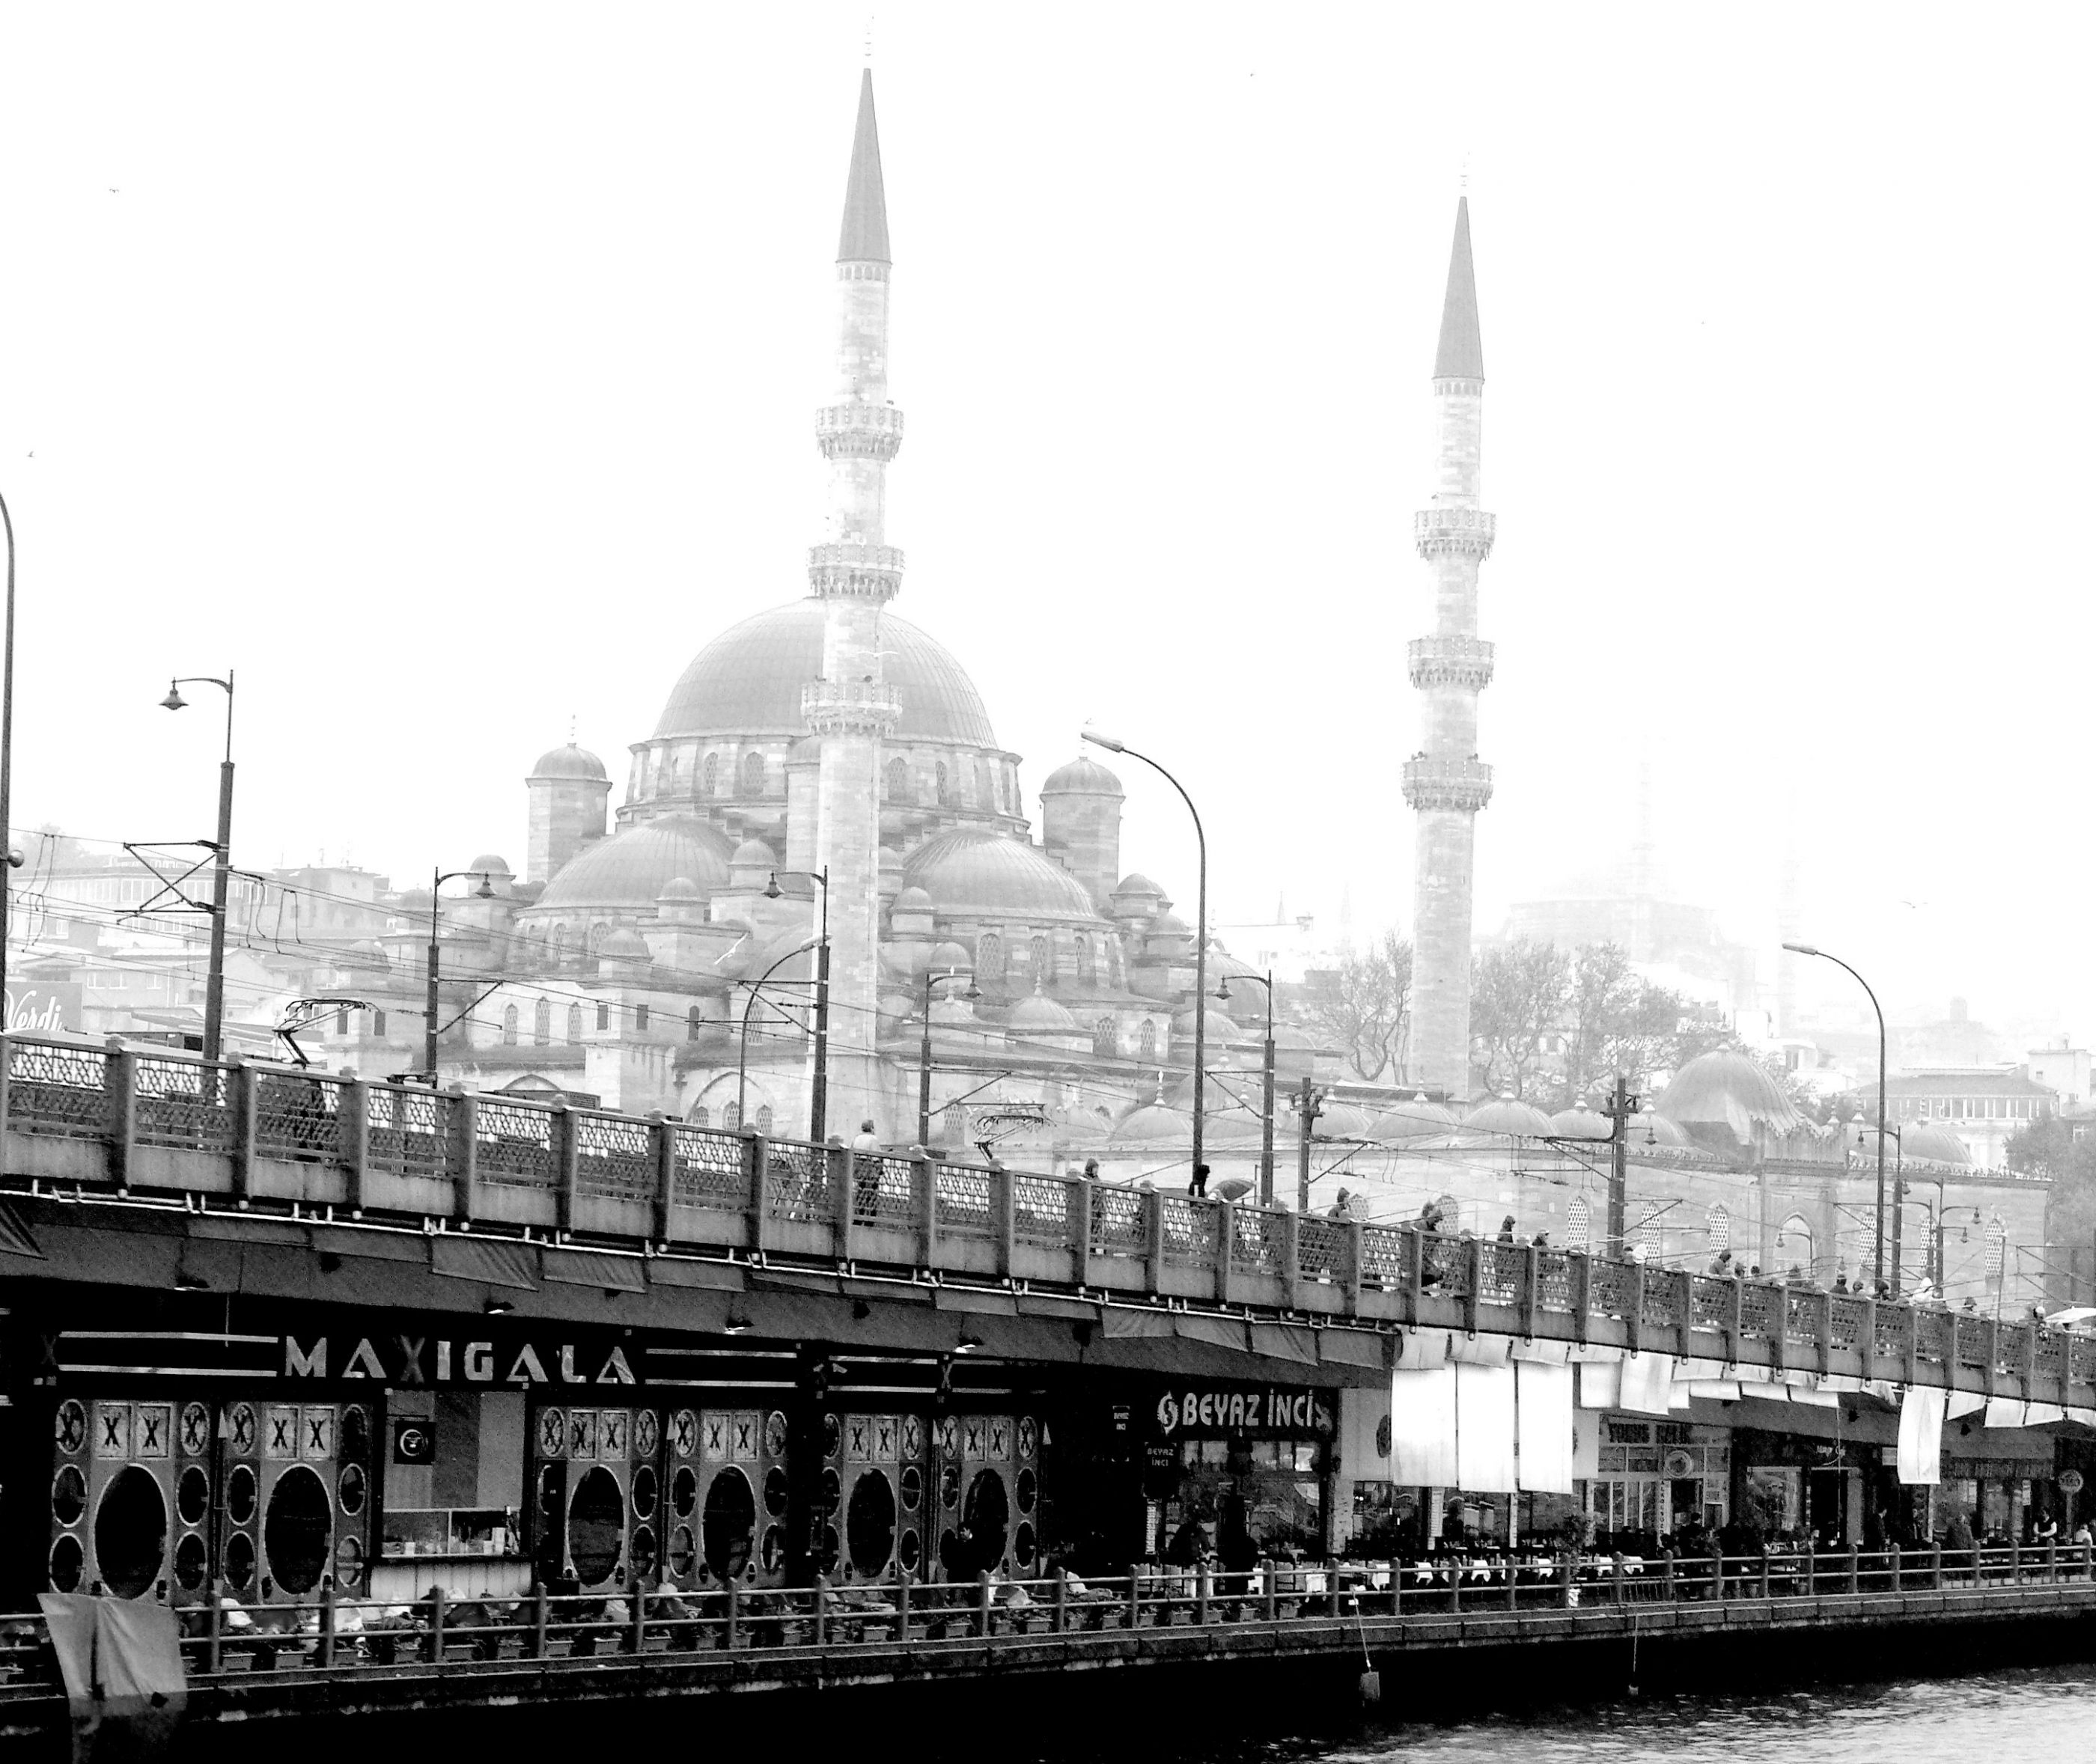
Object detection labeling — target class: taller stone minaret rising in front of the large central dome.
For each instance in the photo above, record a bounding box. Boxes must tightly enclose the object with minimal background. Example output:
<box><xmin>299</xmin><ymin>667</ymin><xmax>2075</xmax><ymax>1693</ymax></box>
<box><xmin>801</xmin><ymin>69</ymin><xmax>904</xmax><ymax>1138</ymax></box>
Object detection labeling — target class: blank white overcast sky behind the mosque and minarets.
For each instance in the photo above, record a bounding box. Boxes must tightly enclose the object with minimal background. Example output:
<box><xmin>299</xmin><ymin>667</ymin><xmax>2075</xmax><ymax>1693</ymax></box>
<box><xmin>0</xmin><ymin>4</ymin><xmax>2096</xmax><ymax>1035</ymax></box>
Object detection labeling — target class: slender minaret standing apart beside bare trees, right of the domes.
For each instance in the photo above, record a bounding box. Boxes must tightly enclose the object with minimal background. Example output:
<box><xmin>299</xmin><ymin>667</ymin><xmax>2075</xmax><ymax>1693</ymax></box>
<box><xmin>1404</xmin><ymin>197</ymin><xmax>1493</xmax><ymax>1098</ymax></box>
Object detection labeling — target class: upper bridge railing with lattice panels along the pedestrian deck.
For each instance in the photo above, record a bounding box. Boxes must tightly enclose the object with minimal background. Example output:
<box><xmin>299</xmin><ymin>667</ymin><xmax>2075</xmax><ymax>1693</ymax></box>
<box><xmin>0</xmin><ymin>1035</ymin><xmax>2096</xmax><ymax>1406</ymax></box>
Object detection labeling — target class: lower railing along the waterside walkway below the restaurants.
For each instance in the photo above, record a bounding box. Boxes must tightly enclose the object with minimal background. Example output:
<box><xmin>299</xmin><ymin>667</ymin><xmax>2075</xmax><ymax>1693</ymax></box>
<box><xmin>0</xmin><ymin>1542</ymin><xmax>2096</xmax><ymax>1701</ymax></box>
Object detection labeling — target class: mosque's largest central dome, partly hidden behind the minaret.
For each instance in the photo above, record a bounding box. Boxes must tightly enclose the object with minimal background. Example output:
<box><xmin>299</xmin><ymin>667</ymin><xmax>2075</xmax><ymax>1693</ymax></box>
<box><xmin>654</xmin><ymin>597</ymin><xmax>998</xmax><ymax>748</ymax></box>
